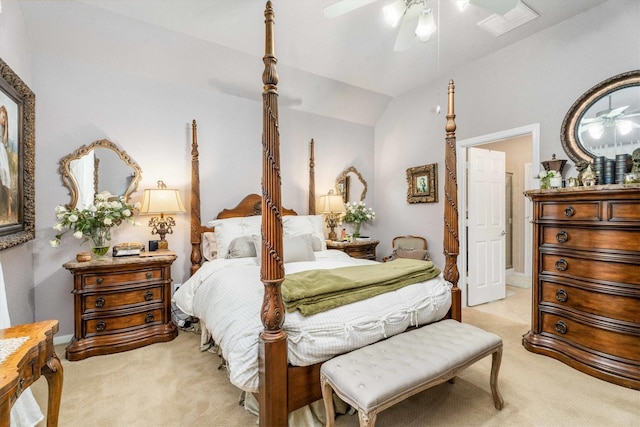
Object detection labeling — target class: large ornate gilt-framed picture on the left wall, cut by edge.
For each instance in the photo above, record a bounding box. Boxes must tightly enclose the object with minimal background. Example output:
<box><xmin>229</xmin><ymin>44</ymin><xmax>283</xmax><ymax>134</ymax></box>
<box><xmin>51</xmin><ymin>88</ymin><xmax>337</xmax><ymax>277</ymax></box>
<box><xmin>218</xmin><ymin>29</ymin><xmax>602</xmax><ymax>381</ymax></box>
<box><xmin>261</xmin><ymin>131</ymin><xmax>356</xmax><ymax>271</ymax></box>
<box><xmin>0</xmin><ymin>59</ymin><xmax>36</xmax><ymax>251</ymax></box>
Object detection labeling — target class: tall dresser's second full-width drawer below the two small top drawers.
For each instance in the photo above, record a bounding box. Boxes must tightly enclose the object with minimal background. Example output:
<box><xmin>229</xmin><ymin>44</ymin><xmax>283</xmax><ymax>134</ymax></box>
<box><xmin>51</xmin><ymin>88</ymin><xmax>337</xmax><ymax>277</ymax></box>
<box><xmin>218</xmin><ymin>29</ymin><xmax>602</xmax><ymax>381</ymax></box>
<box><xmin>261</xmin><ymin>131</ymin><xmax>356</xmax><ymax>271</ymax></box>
<box><xmin>540</xmin><ymin>253</ymin><xmax>640</xmax><ymax>285</ymax></box>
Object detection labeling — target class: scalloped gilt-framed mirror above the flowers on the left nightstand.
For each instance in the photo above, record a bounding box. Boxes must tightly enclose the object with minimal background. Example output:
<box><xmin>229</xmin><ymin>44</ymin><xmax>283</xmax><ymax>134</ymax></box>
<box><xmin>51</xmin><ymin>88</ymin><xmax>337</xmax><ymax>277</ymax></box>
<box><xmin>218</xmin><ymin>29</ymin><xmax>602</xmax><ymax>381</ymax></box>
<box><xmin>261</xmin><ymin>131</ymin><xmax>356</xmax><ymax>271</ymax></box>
<box><xmin>58</xmin><ymin>139</ymin><xmax>142</xmax><ymax>209</ymax></box>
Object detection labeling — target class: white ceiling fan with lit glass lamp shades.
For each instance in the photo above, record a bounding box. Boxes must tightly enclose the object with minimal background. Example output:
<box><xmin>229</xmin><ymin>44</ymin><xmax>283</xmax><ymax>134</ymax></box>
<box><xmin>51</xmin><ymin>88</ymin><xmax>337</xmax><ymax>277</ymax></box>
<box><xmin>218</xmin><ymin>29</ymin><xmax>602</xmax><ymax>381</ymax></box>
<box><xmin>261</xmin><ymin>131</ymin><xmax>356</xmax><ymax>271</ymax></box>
<box><xmin>324</xmin><ymin>0</ymin><xmax>520</xmax><ymax>51</ymax></box>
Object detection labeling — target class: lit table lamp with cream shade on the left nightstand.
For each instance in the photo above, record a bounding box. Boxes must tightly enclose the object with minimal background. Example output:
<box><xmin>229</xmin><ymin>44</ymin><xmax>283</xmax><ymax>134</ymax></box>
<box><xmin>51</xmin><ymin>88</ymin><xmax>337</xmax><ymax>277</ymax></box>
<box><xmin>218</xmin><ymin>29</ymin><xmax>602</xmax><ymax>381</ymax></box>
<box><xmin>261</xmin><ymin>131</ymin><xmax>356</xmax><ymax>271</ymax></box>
<box><xmin>139</xmin><ymin>181</ymin><xmax>186</xmax><ymax>250</ymax></box>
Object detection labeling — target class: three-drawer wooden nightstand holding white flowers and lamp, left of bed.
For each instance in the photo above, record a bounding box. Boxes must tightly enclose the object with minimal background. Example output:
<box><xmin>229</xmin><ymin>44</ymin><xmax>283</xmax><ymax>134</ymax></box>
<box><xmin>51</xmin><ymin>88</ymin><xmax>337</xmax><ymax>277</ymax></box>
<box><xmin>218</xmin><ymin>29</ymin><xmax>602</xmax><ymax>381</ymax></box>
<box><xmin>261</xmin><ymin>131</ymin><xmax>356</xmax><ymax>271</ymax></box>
<box><xmin>63</xmin><ymin>255</ymin><xmax>178</xmax><ymax>360</ymax></box>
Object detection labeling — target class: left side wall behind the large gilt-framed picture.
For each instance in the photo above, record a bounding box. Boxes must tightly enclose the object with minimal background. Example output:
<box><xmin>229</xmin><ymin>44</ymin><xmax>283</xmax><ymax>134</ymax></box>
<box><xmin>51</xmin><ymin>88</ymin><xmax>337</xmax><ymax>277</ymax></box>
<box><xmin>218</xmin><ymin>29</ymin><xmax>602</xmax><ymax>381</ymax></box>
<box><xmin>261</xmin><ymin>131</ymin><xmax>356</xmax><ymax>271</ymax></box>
<box><xmin>0</xmin><ymin>0</ymin><xmax>38</xmax><ymax>325</ymax></box>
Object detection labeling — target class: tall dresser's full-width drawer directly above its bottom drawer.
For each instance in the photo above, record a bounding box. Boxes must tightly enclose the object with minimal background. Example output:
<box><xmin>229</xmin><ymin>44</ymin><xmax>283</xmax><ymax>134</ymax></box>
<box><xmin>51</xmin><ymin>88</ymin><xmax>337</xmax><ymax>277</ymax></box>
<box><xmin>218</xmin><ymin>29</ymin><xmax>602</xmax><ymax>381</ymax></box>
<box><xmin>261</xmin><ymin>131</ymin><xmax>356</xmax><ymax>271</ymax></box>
<box><xmin>541</xmin><ymin>280</ymin><xmax>640</xmax><ymax>323</ymax></box>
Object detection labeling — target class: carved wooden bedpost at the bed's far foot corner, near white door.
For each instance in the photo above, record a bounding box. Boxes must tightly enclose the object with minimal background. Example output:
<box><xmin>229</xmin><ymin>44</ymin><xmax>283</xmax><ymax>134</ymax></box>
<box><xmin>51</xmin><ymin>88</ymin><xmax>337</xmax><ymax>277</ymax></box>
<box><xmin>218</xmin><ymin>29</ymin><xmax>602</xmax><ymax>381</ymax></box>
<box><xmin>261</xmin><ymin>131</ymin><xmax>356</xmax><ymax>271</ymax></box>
<box><xmin>443</xmin><ymin>80</ymin><xmax>462</xmax><ymax>321</ymax></box>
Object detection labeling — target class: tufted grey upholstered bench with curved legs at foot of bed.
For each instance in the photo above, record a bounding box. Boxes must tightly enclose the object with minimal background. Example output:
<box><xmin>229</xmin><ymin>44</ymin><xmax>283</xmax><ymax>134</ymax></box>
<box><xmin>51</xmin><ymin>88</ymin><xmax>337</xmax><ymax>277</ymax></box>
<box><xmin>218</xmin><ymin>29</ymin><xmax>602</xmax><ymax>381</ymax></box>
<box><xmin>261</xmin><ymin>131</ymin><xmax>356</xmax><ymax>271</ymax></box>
<box><xmin>320</xmin><ymin>319</ymin><xmax>504</xmax><ymax>427</ymax></box>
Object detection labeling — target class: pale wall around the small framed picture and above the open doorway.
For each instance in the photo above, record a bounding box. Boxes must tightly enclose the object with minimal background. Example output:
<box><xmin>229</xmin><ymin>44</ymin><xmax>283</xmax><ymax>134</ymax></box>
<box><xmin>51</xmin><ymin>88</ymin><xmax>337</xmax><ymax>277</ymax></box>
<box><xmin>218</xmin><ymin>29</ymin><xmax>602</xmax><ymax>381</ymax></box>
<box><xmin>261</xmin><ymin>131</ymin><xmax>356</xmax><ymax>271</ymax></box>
<box><xmin>375</xmin><ymin>0</ymin><xmax>640</xmax><ymax>265</ymax></box>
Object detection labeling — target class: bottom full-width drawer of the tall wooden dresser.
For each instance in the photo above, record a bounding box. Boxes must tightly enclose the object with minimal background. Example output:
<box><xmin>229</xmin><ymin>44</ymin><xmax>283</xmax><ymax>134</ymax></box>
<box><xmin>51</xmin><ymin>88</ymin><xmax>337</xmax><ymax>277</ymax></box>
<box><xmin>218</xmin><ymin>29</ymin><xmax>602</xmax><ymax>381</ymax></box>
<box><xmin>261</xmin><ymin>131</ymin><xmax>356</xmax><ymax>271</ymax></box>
<box><xmin>541</xmin><ymin>312</ymin><xmax>640</xmax><ymax>361</ymax></box>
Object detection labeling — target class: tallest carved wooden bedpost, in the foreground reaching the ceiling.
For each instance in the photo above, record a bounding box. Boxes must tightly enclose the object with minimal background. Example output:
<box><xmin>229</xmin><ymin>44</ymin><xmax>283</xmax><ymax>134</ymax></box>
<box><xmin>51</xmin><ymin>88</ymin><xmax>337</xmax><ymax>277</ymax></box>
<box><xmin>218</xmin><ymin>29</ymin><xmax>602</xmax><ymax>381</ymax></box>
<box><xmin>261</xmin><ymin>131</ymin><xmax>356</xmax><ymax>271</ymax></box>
<box><xmin>258</xmin><ymin>1</ymin><xmax>287</xmax><ymax>427</ymax></box>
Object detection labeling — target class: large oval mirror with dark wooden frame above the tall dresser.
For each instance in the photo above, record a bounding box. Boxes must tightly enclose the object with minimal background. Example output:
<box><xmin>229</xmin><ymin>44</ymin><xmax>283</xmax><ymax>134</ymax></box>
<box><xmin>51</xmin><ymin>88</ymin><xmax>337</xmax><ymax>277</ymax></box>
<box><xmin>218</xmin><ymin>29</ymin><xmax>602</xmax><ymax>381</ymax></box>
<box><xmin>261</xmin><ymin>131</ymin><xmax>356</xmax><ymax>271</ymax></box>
<box><xmin>561</xmin><ymin>70</ymin><xmax>640</xmax><ymax>163</ymax></box>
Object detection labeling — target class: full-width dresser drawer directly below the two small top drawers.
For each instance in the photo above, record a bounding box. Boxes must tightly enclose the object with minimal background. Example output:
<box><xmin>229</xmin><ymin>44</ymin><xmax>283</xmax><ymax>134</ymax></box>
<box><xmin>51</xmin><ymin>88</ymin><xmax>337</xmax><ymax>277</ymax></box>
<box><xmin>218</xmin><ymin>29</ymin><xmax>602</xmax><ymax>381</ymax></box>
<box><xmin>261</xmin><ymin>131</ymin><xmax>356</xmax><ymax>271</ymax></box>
<box><xmin>541</xmin><ymin>227</ymin><xmax>640</xmax><ymax>256</ymax></box>
